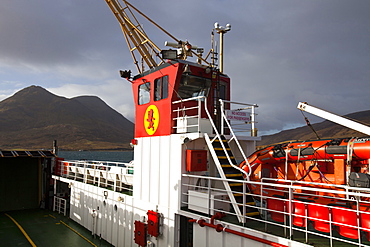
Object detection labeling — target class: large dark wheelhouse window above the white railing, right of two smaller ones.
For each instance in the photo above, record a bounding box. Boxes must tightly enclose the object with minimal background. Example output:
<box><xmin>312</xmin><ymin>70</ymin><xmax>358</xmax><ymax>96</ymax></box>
<box><xmin>178</xmin><ymin>75</ymin><xmax>211</xmax><ymax>99</ymax></box>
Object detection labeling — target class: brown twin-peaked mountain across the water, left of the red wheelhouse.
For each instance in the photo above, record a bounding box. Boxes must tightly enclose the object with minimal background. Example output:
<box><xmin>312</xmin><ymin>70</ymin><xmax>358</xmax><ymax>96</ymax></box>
<box><xmin>0</xmin><ymin>86</ymin><xmax>134</xmax><ymax>150</ymax></box>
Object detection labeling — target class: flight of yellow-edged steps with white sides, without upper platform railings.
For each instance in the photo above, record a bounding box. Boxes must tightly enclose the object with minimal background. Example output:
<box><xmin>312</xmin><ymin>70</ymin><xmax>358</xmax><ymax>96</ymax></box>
<box><xmin>205</xmin><ymin>134</ymin><xmax>258</xmax><ymax>223</ymax></box>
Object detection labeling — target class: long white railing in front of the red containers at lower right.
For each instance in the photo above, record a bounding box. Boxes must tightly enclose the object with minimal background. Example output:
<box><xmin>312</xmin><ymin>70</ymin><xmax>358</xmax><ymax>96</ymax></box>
<box><xmin>181</xmin><ymin>174</ymin><xmax>370</xmax><ymax>246</ymax></box>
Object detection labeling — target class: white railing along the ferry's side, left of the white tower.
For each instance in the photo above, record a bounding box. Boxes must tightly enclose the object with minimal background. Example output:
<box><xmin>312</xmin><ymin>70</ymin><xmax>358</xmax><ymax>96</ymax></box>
<box><xmin>54</xmin><ymin>160</ymin><xmax>134</xmax><ymax>195</ymax></box>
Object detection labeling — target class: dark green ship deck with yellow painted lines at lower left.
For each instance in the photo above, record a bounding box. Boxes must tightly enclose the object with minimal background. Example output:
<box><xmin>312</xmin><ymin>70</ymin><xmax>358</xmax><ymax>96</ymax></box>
<box><xmin>0</xmin><ymin>209</ymin><xmax>112</xmax><ymax>247</ymax></box>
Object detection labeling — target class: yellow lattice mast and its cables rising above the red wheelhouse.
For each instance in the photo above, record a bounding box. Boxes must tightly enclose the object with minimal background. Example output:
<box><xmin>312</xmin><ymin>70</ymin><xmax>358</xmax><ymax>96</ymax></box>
<box><xmin>105</xmin><ymin>0</ymin><xmax>210</xmax><ymax>73</ymax></box>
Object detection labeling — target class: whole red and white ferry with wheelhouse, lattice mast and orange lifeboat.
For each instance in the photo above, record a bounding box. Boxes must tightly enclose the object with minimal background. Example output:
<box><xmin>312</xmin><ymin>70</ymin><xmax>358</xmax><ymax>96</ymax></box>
<box><xmin>52</xmin><ymin>0</ymin><xmax>370</xmax><ymax>247</ymax></box>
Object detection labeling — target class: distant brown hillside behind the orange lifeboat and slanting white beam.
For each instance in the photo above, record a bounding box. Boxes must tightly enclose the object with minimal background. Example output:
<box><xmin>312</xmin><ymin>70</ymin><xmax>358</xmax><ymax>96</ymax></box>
<box><xmin>258</xmin><ymin>110</ymin><xmax>370</xmax><ymax>146</ymax></box>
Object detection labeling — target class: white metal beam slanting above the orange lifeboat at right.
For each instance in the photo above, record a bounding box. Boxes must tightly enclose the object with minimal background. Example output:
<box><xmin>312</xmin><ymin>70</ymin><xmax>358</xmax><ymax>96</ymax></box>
<box><xmin>297</xmin><ymin>102</ymin><xmax>370</xmax><ymax>135</ymax></box>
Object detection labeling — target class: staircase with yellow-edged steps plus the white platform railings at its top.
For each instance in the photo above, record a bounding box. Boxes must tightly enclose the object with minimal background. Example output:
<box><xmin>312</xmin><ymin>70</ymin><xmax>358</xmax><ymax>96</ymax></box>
<box><xmin>173</xmin><ymin>96</ymin><xmax>259</xmax><ymax>223</ymax></box>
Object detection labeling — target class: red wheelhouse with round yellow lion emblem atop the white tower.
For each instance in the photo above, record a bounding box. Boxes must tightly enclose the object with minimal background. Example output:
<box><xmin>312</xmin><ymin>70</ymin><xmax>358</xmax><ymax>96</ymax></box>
<box><xmin>132</xmin><ymin>60</ymin><xmax>230</xmax><ymax>138</ymax></box>
